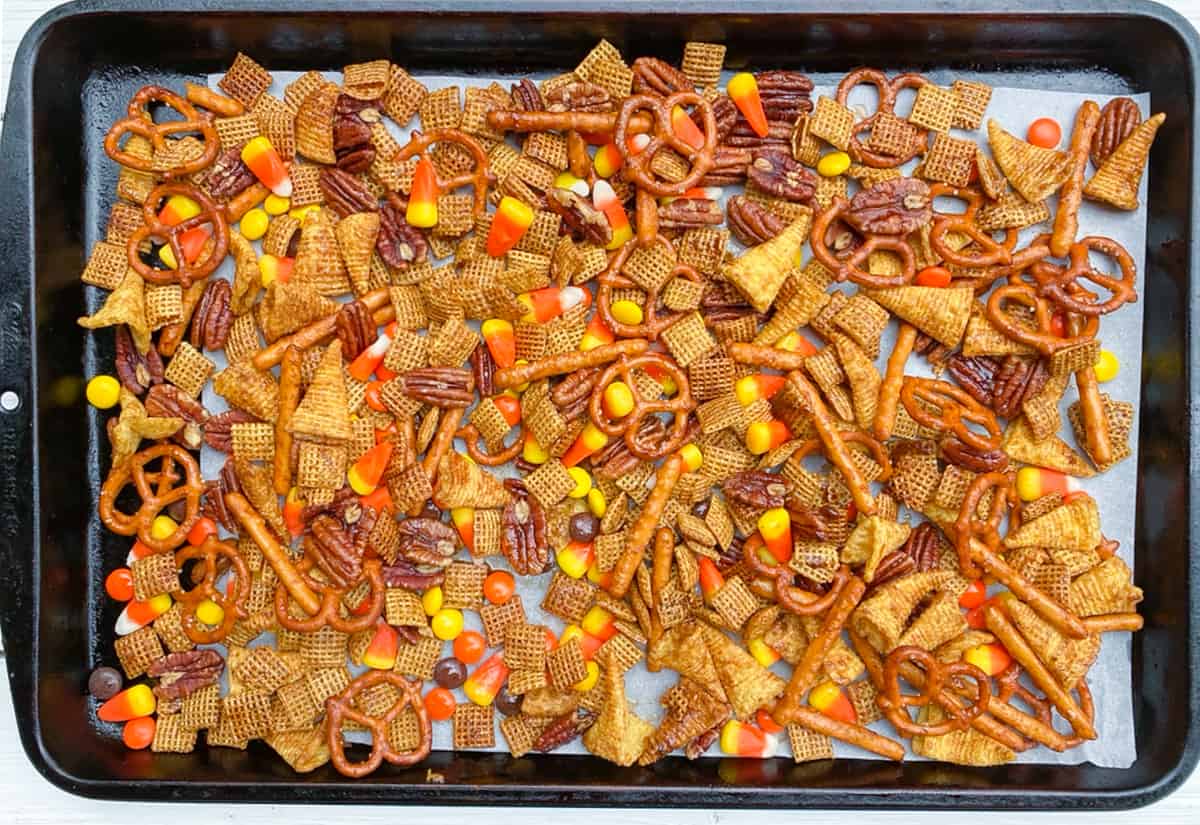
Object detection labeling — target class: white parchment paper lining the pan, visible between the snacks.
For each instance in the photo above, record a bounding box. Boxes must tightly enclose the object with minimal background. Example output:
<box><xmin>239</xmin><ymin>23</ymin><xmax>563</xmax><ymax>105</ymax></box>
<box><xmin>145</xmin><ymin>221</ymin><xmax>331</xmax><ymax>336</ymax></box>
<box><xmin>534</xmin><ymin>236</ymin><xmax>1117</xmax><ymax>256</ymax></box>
<box><xmin>202</xmin><ymin>67</ymin><xmax>1151</xmax><ymax>767</ymax></box>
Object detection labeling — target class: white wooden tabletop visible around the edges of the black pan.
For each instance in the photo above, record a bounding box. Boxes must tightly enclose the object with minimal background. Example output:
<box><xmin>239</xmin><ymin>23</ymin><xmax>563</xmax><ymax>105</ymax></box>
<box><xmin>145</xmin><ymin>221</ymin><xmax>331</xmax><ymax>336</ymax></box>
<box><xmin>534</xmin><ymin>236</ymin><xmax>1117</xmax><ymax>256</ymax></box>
<box><xmin>0</xmin><ymin>0</ymin><xmax>1200</xmax><ymax>825</ymax></box>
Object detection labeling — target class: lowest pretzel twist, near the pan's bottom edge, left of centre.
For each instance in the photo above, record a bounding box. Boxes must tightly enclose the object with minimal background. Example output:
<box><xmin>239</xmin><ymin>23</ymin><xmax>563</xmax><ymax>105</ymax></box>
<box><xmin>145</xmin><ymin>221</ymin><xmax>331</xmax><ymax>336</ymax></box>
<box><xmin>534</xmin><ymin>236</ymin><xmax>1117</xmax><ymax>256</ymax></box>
<box><xmin>325</xmin><ymin>670</ymin><xmax>433</xmax><ymax>779</ymax></box>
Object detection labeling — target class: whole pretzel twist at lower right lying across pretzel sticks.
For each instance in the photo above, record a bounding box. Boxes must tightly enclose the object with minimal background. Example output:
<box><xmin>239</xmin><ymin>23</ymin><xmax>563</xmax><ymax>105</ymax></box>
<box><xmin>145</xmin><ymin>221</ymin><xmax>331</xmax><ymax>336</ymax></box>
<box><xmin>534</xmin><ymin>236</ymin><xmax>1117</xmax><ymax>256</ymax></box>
<box><xmin>877</xmin><ymin>645</ymin><xmax>991</xmax><ymax>736</ymax></box>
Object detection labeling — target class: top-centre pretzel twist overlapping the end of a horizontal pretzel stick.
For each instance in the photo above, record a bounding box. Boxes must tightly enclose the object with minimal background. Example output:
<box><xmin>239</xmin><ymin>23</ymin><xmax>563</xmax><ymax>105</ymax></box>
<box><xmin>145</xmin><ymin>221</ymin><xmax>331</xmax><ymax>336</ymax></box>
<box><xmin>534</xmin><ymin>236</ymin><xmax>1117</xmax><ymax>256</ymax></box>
<box><xmin>613</xmin><ymin>91</ymin><xmax>716</xmax><ymax>198</ymax></box>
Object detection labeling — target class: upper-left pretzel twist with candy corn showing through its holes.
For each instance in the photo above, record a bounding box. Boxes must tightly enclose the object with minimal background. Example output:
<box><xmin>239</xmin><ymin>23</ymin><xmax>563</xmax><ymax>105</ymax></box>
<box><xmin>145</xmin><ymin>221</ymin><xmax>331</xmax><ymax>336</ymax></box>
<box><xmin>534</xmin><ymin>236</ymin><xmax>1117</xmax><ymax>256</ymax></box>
<box><xmin>126</xmin><ymin>182</ymin><xmax>229</xmax><ymax>289</ymax></box>
